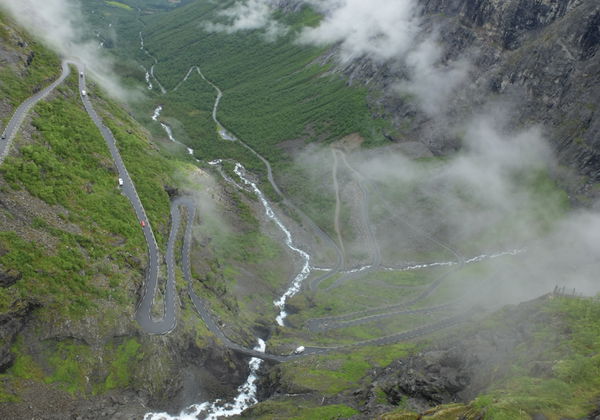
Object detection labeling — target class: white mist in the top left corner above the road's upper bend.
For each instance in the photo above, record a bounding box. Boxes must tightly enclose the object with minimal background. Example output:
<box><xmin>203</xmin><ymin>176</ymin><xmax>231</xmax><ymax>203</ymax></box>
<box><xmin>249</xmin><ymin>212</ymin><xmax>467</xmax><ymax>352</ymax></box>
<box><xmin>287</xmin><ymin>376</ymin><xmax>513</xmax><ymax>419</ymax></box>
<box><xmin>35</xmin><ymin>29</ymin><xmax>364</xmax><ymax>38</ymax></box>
<box><xmin>0</xmin><ymin>0</ymin><xmax>133</xmax><ymax>100</ymax></box>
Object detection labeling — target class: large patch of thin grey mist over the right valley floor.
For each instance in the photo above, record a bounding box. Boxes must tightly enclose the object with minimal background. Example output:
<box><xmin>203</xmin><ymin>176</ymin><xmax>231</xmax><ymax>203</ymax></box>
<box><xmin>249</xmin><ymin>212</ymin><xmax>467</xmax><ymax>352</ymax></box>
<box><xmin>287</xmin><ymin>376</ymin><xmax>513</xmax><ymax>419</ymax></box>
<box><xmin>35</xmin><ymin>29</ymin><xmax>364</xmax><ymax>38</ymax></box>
<box><xmin>296</xmin><ymin>104</ymin><xmax>600</xmax><ymax>307</ymax></box>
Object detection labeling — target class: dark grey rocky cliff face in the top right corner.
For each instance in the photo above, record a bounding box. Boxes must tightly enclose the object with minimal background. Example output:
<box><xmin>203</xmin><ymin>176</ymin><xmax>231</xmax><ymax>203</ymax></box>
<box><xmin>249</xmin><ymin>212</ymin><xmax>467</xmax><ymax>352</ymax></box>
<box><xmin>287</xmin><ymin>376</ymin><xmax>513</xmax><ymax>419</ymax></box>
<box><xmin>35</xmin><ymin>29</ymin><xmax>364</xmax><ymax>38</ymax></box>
<box><xmin>425</xmin><ymin>0</ymin><xmax>600</xmax><ymax>181</ymax></box>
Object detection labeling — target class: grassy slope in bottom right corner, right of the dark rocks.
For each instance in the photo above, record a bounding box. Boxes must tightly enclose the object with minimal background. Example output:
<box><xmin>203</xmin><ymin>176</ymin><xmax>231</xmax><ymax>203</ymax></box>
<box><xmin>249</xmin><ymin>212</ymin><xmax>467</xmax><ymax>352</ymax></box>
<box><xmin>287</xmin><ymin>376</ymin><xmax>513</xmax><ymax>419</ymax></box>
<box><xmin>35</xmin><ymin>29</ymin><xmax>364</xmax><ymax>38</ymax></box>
<box><xmin>382</xmin><ymin>298</ymin><xmax>600</xmax><ymax>420</ymax></box>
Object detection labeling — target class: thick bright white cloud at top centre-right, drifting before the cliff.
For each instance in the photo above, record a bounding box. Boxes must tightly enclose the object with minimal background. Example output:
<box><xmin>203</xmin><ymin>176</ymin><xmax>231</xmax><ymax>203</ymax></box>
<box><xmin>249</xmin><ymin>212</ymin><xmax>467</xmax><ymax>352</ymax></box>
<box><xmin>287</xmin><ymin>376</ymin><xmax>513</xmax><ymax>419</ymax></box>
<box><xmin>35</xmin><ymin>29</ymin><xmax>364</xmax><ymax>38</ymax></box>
<box><xmin>299</xmin><ymin>0</ymin><xmax>469</xmax><ymax>116</ymax></box>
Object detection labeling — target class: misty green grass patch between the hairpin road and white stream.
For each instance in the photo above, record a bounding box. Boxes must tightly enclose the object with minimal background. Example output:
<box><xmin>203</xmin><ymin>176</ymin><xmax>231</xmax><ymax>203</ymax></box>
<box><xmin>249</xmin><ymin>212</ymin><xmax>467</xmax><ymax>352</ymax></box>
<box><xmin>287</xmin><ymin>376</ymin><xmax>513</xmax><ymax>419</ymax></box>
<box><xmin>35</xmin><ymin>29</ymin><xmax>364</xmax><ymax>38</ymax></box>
<box><xmin>192</xmin><ymin>183</ymin><xmax>292</xmax><ymax>327</ymax></box>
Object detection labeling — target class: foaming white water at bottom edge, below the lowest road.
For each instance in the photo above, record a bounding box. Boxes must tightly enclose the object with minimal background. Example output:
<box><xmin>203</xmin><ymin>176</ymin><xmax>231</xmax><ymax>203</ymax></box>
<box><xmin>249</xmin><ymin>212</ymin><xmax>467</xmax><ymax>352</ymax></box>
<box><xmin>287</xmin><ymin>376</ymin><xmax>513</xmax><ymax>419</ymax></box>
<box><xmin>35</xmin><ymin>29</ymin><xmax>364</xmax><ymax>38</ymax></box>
<box><xmin>144</xmin><ymin>338</ymin><xmax>267</xmax><ymax>420</ymax></box>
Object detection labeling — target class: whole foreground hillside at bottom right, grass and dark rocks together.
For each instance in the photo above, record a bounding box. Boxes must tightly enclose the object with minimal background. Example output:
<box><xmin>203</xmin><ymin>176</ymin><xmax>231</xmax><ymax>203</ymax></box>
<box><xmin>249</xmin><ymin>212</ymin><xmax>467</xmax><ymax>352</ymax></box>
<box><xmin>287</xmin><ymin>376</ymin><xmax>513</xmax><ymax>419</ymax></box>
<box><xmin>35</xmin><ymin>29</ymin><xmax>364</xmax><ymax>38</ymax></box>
<box><xmin>243</xmin><ymin>294</ymin><xmax>600</xmax><ymax>420</ymax></box>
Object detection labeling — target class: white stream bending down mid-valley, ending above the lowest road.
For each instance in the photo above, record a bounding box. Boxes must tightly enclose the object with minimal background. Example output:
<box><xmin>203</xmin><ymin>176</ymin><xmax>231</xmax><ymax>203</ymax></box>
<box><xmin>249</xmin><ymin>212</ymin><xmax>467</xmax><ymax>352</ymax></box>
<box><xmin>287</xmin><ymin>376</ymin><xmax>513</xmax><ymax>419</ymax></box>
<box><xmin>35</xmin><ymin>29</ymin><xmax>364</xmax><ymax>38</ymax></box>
<box><xmin>234</xmin><ymin>162</ymin><xmax>311</xmax><ymax>327</ymax></box>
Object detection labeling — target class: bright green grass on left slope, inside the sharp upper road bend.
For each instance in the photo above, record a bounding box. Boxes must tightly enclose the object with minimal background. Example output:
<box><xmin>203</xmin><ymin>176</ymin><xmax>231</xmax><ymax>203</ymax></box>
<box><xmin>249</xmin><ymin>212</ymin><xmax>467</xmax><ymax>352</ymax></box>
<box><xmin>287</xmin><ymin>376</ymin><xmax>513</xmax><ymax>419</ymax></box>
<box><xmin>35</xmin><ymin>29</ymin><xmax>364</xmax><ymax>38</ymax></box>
<box><xmin>0</xmin><ymin>71</ymin><xmax>155</xmax><ymax>316</ymax></box>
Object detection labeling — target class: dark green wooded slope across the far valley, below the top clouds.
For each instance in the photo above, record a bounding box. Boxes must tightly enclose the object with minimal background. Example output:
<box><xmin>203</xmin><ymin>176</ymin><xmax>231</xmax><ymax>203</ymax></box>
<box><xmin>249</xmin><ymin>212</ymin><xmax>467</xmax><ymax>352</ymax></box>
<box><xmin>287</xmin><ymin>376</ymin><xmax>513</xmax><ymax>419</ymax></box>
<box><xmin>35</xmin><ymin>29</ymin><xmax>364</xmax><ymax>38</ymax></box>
<box><xmin>144</xmin><ymin>2</ymin><xmax>384</xmax><ymax>160</ymax></box>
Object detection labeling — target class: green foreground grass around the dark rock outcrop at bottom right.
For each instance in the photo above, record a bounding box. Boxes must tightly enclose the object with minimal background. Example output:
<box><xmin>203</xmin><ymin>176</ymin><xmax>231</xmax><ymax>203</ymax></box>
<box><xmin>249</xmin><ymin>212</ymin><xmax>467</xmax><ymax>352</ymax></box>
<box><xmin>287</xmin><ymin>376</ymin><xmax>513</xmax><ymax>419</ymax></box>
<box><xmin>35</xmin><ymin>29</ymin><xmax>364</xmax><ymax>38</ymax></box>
<box><xmin>248</xmin><ymin>297</ymin><xmax>600</xmax><ymax>420</ymax></box>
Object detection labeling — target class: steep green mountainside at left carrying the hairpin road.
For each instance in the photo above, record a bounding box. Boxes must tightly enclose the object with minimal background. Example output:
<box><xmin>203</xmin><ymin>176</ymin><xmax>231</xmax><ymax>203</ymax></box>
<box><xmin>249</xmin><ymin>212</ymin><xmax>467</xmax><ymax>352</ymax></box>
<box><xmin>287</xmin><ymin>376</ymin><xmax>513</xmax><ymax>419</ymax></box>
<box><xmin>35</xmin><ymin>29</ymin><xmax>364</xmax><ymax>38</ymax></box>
<box><xmin>0</xmin><ymin>16</ymin><xmax>264</xmax><ymax>419</ymax></box>
